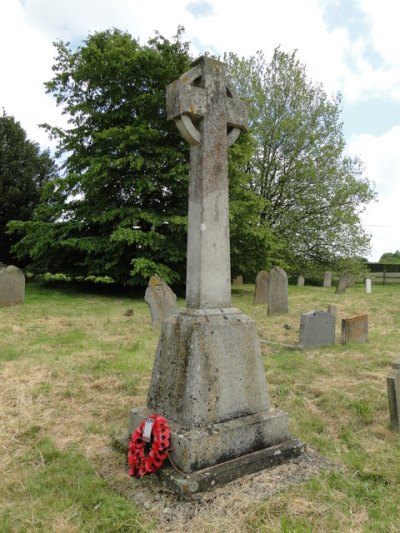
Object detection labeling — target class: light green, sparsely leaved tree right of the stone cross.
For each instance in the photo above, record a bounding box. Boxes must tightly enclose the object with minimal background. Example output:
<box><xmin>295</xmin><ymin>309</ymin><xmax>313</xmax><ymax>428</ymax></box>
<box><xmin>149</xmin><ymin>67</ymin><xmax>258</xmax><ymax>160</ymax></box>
<box><xmin>225</xmin><ymin>48</ymin><xmax>374</xmax><ymax>270</ymax></box>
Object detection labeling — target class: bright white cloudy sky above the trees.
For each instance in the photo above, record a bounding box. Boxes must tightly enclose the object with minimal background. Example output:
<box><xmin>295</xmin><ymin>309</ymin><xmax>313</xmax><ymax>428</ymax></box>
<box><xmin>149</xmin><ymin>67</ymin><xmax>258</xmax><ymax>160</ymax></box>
<box><xmin>0</xmin><ymin>0</ymin><xmax>400</xmax><ymax>261</ymax></box>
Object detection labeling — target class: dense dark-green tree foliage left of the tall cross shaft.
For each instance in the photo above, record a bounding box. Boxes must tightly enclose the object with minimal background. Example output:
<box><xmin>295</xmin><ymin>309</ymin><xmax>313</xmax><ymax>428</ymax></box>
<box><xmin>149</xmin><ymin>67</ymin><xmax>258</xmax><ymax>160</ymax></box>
<box><xmin>12</xmin><ymin>29</ymin><xmax>190</xmax><ymax>284</ymax></box>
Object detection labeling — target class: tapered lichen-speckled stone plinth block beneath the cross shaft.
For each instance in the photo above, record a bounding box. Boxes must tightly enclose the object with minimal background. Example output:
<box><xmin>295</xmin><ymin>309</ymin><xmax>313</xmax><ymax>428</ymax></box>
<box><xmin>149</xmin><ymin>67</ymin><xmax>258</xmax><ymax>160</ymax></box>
<box><xmin>147</xmin><ymin>308</ymin><xmax>269</xmax><ymax>428</ymax></box>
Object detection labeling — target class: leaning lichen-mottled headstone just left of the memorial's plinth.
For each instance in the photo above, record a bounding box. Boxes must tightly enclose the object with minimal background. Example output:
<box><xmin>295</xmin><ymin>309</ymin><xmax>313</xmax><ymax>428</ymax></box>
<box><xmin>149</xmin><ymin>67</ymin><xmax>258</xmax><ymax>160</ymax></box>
<box><xmin>144</xmin><ymin>274</ymin><xmax>176</xmax><ymax>327</ymax></box>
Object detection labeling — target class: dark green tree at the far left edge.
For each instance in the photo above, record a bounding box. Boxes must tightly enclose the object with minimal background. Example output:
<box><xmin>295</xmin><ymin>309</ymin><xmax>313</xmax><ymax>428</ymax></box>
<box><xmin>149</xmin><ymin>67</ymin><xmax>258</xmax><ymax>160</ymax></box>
<box><xmin>0</xmin><ymin>111</ymin><xmax>55</xmax><ymax>266</ymax></box>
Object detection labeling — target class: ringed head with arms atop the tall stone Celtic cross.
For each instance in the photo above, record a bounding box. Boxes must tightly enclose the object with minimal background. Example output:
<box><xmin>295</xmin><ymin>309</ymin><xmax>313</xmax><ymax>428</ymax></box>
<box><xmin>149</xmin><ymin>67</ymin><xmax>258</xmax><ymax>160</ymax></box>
<box><xmin>167</xmin><ymin>56</ymin><xmax>248</xmax><ymax>146</ymax></box>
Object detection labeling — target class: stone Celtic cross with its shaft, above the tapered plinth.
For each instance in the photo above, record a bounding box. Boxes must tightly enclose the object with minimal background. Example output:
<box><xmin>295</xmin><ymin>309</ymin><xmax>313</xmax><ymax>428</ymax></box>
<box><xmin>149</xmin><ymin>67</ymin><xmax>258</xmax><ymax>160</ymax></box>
<box><xmin>167</xmin><ymin>56</ymin><xmax>248</xmax><ymax>309</ymax></box>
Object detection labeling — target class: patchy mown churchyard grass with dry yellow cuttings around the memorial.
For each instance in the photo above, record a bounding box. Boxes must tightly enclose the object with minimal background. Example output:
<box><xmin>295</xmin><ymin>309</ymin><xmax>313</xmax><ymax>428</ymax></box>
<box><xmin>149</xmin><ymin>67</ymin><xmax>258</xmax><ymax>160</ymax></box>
<box><xmin>0</xmin><ymin>284</ymin><xmax>400</xmax><ymax>533</ymax></box>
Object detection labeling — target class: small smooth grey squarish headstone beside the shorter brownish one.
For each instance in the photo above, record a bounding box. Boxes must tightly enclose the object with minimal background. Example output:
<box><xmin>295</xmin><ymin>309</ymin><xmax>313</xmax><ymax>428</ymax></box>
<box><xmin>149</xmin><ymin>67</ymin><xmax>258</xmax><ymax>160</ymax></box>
<box><xmin>299</xmin><ymin>311</ymin><xmax>336</xmax><ymax>349</ymax></box>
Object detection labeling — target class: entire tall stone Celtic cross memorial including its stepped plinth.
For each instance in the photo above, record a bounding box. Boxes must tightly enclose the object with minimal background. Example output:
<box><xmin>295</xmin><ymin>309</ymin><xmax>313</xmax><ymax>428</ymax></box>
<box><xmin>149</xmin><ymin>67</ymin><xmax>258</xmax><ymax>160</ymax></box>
<box><xmin>129</xmin><ymin>57</ymin><xmax>303</xmax><ymax>494</ymax></box>
